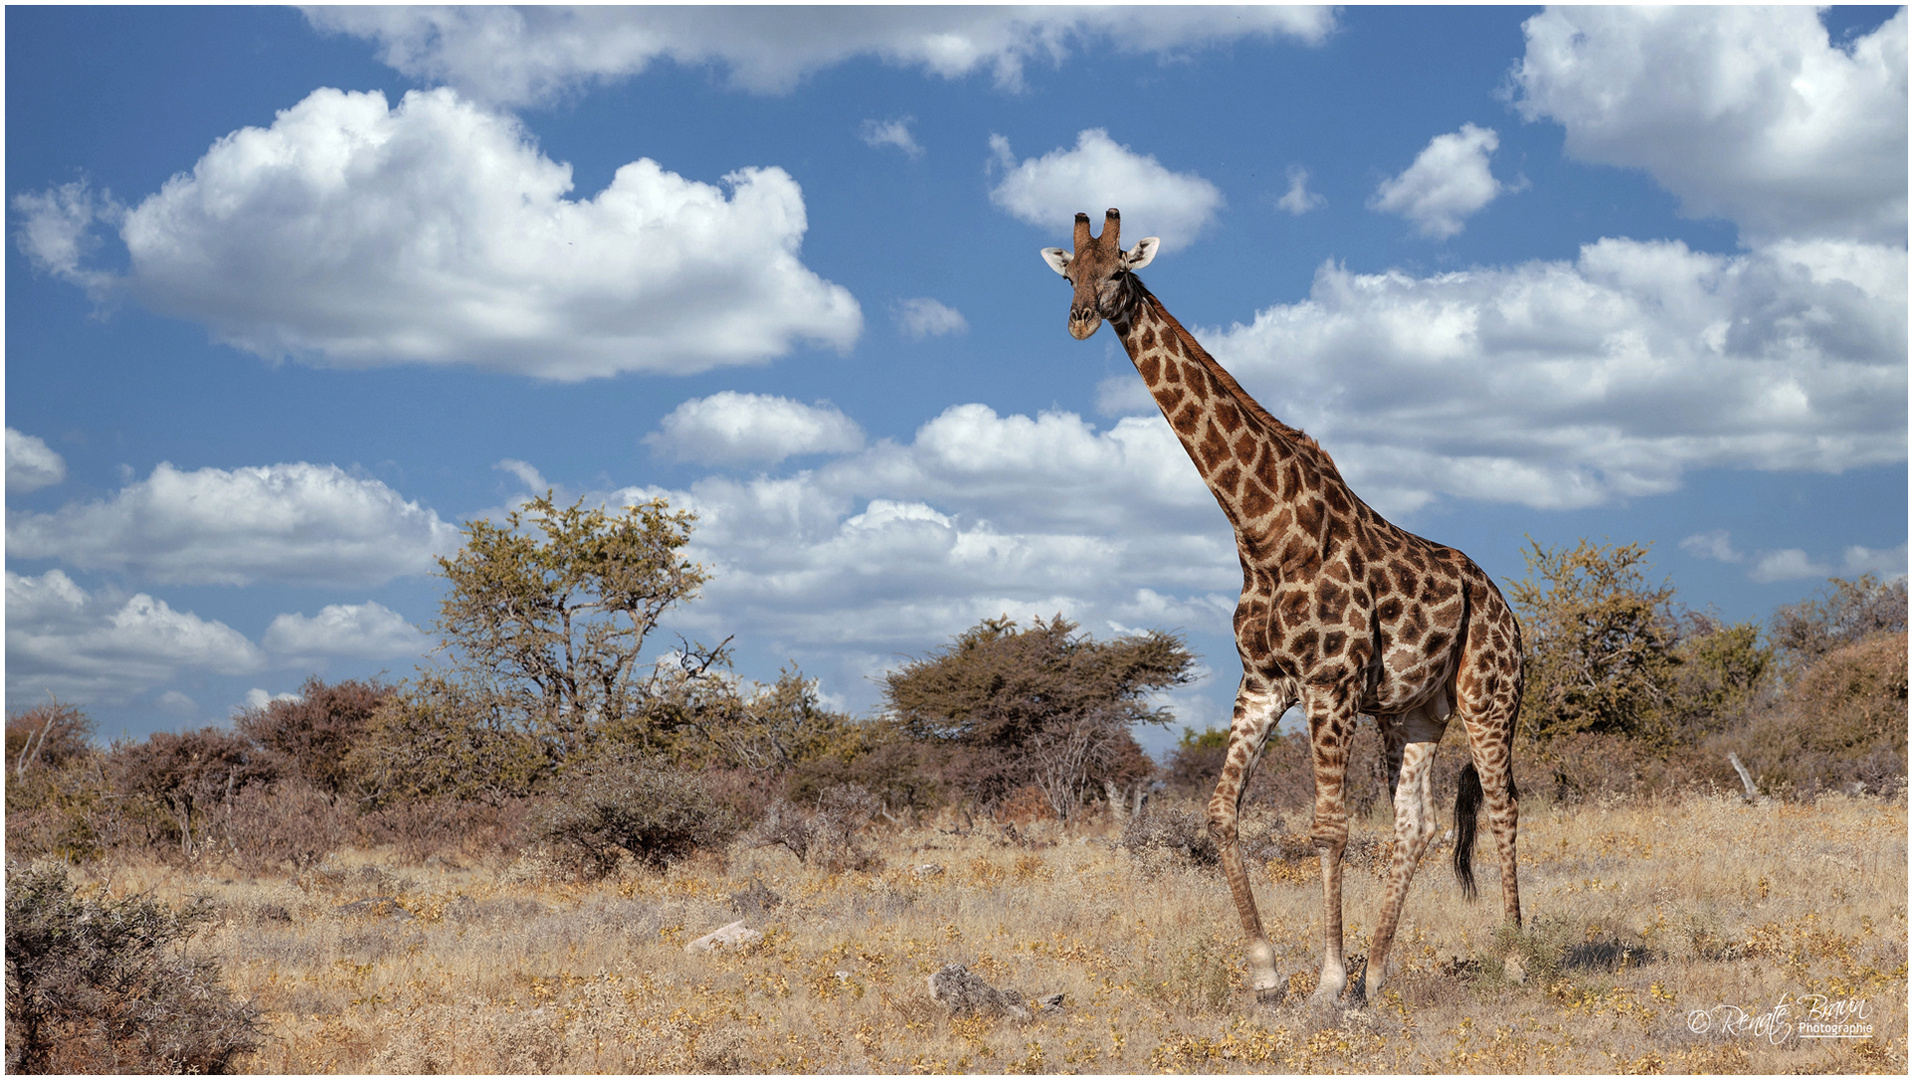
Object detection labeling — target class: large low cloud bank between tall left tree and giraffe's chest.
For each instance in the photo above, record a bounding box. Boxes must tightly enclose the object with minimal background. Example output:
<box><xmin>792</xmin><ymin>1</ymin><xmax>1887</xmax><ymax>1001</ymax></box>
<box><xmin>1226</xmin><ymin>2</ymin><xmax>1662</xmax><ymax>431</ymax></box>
<box><xmin>595</xmin><ymin>403</ymin><xmax>1240</xmax><ymax>686</ymax></box>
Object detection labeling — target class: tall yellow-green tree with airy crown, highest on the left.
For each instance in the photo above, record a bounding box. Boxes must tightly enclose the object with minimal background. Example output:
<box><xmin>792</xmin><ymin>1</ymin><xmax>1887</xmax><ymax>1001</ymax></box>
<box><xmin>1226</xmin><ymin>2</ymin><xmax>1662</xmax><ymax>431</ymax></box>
<box><xmin>436</xmin><ymin>491</ymin><xmax>706</xmax><ymax>759</ymax></box>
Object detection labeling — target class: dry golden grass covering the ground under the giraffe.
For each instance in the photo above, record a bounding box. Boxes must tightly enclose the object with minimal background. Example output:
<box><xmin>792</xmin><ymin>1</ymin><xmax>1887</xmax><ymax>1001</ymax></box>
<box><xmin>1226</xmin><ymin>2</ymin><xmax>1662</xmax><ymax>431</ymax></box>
<box><xmin>55</xmin><ymin>795</ymin><xmax>1907</xmax><ymax>1072</ymax></box>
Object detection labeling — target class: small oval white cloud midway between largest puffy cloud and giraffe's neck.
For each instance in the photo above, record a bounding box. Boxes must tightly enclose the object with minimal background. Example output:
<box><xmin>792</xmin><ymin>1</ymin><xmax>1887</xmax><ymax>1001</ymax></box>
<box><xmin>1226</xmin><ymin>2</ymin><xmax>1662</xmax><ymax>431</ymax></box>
<box><xmin>645</xmin><ymin>390</ymin><xmax>863</xmax><ymax>464</ymax></box>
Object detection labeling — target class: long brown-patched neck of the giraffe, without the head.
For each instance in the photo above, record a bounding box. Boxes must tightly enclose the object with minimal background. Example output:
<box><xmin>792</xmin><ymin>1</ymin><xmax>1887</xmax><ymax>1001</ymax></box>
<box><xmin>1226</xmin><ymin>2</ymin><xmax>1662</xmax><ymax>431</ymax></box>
<box><xmin>1110</xmin><ymin>275</ymin><xmax>1341</xmax><ymax>535</ymax></box>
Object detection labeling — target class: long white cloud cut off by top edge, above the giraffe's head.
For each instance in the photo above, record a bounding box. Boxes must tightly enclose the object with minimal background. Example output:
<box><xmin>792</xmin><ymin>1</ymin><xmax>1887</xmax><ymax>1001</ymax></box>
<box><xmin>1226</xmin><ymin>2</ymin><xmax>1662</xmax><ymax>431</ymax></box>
<box><xmin>306</xmin><ymin>6</ymin><xmax>1335</xmax><ymax>103</ymax></box>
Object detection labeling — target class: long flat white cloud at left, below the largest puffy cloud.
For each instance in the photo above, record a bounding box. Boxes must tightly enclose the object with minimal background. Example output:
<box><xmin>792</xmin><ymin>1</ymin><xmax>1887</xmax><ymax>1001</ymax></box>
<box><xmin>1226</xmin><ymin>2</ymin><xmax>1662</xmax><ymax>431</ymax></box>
<box><xmin>6</xmin><ymin>463</ymin><xmax>459</xmax><ymax>585</ymax></box>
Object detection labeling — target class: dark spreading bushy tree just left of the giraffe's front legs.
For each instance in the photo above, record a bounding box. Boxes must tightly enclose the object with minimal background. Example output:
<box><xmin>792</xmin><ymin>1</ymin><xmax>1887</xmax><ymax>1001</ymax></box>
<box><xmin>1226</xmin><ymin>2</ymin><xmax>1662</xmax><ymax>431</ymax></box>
<box><xmin>884</xmin><ymin>616</ymin><xmax>1196</xmax><ymax>820</ymax></box>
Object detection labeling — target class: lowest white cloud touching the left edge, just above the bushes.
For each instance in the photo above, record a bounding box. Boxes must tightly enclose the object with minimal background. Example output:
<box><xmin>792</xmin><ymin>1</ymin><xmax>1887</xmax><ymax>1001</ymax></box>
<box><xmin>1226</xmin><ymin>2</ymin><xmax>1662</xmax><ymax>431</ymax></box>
<box><xmin>6</xmin><ymin>570</ymin><xmax>266</xmax><ymax>703</ymax></box>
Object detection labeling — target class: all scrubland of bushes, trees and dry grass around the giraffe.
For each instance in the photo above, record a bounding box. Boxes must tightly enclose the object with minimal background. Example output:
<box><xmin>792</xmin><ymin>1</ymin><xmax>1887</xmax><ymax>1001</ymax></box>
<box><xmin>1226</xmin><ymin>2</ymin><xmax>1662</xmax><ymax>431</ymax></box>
<box><xmin>6</xmin><ymin>501</ymin><xmax>1907</xmax><ymax>1072</ymax></box>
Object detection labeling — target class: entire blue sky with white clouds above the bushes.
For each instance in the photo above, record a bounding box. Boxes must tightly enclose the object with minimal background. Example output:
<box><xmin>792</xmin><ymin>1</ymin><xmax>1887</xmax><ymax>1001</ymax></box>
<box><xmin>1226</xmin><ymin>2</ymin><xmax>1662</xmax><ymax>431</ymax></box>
<box><xmin>6</xmin><ymin>8</ymin><xmax>1907</xmax><ymax>747</ymax></box>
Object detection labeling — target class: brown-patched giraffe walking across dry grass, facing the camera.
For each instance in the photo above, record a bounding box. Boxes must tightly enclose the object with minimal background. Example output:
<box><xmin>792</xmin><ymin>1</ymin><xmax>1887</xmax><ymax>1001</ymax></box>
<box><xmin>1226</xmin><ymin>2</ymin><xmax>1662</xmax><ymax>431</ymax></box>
<box><xmin>1043</xmin><ymin>208</ymin><xmax>1521</xmax><ymax>1004</ymax></box>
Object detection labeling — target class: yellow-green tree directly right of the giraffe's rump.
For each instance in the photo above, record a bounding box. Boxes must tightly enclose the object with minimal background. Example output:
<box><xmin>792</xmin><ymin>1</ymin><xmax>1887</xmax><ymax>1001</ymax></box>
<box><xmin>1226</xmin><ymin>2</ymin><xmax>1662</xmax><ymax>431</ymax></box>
<box><xmin>1509</xmin><ymin>539</ymin><xmax>1680</xmax><ymax>742</ymax></box>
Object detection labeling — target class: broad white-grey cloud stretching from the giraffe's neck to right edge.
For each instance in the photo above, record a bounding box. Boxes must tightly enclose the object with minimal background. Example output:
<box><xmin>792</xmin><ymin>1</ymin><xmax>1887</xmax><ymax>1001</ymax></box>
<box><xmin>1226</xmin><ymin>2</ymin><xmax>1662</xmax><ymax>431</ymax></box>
<box><xmin>1198</xmin><ymin>239</ymin><xmax>1907</xmax><ymax>512</ymax></box>
